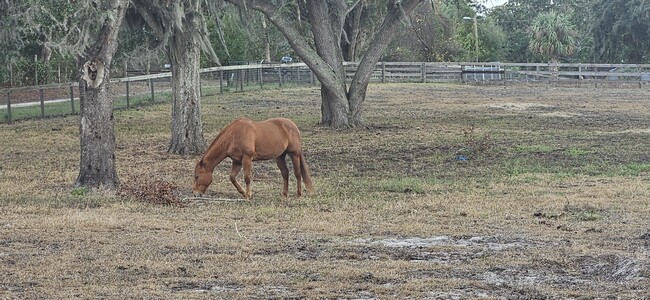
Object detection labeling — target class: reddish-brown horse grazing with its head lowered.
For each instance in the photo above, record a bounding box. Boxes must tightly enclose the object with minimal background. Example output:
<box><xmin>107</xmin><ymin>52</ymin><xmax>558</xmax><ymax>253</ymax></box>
<box><xmin>192</xmin><ymin>118</ymin><xmax>313</xmax><ymax>199</ymax></box>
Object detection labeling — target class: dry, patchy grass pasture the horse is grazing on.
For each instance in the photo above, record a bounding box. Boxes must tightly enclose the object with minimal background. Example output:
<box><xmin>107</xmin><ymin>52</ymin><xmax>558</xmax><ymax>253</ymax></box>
<box><xmin>0</xmin><ymin>84</ymin><xmax>650</xmax><ymax>299</ymax></box>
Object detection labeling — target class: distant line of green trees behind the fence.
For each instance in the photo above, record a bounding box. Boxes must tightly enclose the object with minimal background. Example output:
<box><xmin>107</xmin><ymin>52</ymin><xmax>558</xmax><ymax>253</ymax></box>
<box><xmin>0</xmin><ymin>0</ymin><xmax>650</xmax><ymax>85</ymax></box>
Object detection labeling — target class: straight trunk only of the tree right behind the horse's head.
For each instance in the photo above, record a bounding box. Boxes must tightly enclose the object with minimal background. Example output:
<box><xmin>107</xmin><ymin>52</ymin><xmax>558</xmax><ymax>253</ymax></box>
<box><xmin>167</xmin><ymin>15</ymin><xmax>205</xmax><ymax>155</ymax></box>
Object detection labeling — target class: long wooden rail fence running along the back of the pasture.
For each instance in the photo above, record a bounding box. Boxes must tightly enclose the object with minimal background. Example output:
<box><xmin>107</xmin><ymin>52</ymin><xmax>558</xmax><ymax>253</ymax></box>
<box><xmin>0</xmin><ymin>62</ymin><xmax>650</xmax><ymax>123</ymax></box>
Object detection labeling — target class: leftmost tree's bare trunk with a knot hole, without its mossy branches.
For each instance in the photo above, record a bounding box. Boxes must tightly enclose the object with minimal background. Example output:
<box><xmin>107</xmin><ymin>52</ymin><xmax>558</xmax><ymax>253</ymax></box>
<box><xmin>75</xmin><ymin>0</ymin><xmax>129</xmax><ymax>188</ymax></box>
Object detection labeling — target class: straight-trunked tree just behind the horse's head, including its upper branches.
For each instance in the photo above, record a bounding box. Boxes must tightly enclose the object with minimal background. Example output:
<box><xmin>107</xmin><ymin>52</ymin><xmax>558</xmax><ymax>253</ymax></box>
<box><xmin>129</xmin><ymin>0</ymin><xmax>218</xmax><ymax>155</ymax></box>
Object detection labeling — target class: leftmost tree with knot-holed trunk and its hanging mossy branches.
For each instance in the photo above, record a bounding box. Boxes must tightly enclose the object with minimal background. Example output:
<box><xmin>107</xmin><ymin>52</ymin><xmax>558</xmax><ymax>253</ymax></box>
<box><xmin>6</xmin><ymin>0</ymin><xmax>129</xmax><ymax>188</ymax></box>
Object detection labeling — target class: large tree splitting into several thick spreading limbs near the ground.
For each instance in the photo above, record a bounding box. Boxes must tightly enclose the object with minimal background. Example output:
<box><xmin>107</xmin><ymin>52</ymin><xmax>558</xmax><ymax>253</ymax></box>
<box><xmin>227</xmin><ymin>0</ymin><xmax>430</xmax><ymax>128</ymax></box>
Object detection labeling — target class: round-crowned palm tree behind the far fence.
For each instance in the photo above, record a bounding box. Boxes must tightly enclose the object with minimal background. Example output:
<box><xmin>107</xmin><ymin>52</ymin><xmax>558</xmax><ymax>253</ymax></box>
<box><xmin>528</xmin><ymin>11</ymin><xmax>577</xmax><ymax>74</ymax></box>
